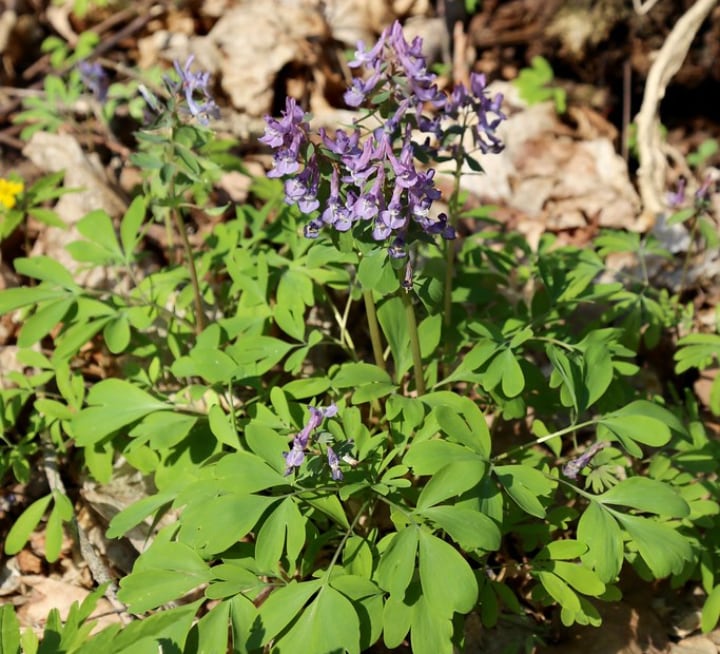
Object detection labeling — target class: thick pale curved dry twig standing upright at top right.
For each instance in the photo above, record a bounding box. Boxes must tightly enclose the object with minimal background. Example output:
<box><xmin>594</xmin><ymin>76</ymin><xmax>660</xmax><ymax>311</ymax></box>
<box><xmin>635</xmin><ymin>0</ymin><xmax>717</xmax><ymax>229</ymax></box>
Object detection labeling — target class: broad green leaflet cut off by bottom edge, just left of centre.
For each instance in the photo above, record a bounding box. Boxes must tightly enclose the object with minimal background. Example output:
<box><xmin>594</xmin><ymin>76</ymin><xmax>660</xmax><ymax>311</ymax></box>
<box><xmin>276</xmin><ymin>586</ymin><xmax>360</xmax><ymax>654</ymax></box>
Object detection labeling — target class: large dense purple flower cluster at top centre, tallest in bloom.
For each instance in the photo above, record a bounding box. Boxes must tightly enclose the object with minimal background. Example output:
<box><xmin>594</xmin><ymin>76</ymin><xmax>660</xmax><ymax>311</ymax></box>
<box><xmin>260</xmin><ymin>22</ymin><xmax>504</xmax><ymax>258</ymax></box>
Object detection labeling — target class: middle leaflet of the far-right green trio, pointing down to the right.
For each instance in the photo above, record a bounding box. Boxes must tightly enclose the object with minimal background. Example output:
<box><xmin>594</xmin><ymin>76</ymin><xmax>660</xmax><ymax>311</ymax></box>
<box><xmin>615</xmin><ymin>513</ymin><xmax>693</xmax><ymax>579</ymax></box>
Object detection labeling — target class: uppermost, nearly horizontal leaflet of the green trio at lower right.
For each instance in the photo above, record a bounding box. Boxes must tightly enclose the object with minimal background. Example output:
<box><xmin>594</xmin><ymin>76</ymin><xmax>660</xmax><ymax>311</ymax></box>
<box><xmin>595</xmin><ymin>477</ymin><xmax>690</xmax><ymax>518</ymax></box>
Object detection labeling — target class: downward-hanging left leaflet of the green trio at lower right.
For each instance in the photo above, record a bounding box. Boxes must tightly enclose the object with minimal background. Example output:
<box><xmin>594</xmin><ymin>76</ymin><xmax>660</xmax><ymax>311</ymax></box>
<box><xmin>577</xmin><ymin>502</ymin><xmax>623</xmax><ymax>583</ymax></box>
